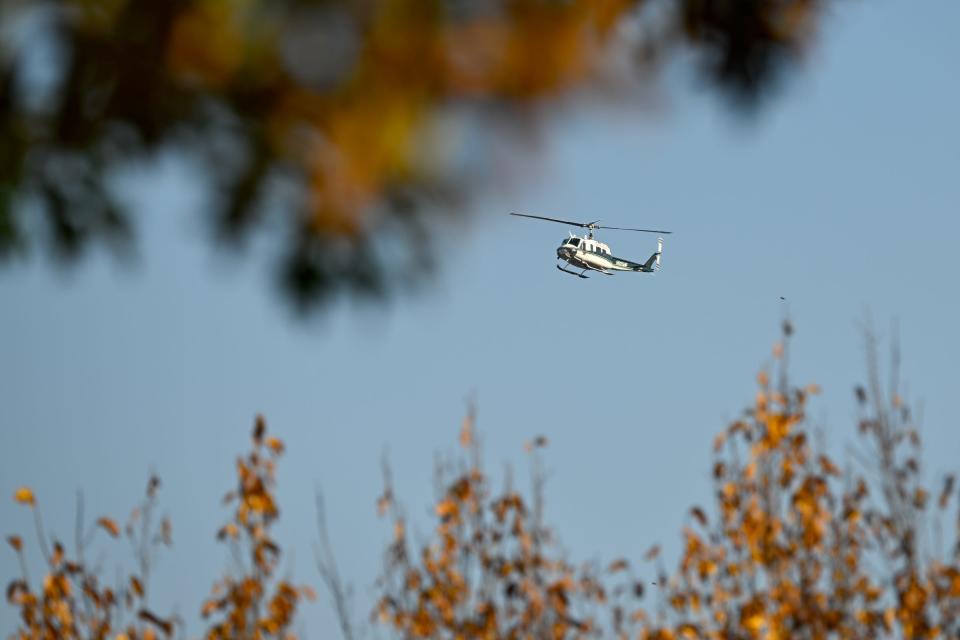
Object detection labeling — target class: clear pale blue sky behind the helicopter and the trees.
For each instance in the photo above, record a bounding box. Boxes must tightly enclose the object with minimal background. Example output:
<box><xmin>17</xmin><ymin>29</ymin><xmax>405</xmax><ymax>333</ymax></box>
<box><xmin>0</xmin><ymin>0</ymin><xmax>960</xmax><ymax>637</ymax></box>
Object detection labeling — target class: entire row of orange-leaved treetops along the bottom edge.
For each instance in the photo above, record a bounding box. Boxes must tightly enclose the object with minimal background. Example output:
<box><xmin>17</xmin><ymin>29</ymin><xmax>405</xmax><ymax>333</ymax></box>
<box><xmin>7</xmin><ymin>325</ymin><xmax>960</xmax><ymax>640</ymax></box>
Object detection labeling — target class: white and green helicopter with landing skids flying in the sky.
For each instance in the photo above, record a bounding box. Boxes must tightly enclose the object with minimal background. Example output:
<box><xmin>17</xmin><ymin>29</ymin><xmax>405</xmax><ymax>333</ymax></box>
<box><xmin>510</xmin><ymin>213</ymin><xmax>671</xmax><ymax>279</ymax></box>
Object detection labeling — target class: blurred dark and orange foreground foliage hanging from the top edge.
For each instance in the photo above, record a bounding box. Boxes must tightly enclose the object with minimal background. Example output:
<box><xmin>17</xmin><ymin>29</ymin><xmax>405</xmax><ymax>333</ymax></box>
<box><xmin>0</xmin><ymin>0</ymin><xmax>824</xmax><ymax>306</ymax></box>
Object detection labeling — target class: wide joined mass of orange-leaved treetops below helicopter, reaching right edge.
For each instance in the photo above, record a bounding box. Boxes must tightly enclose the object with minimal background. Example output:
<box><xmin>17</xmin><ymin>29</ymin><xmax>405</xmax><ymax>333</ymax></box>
<box><xmin>377</xmin><ymin>325</ymin><xmax>960</xmax><ymax>640</ymax></box>
